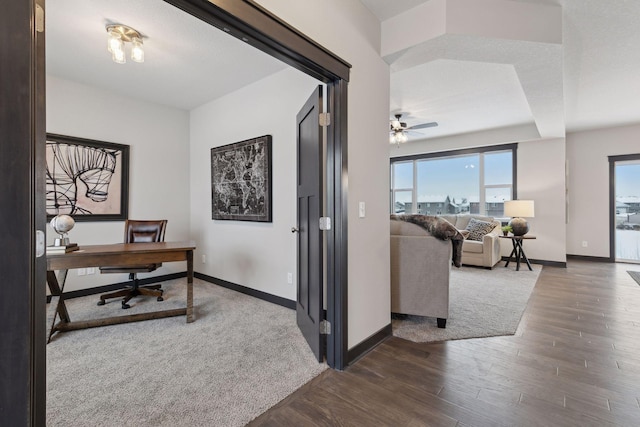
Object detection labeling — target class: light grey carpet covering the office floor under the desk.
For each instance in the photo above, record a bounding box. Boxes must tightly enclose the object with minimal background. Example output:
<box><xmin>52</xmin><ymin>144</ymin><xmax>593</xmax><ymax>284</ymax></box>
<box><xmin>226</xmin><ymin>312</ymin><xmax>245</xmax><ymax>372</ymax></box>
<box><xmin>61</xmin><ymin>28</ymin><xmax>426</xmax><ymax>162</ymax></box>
<box><xmin>47</xmin><ymin>279</ymin><xmax>327</xmax><ymax>427</ymax></box>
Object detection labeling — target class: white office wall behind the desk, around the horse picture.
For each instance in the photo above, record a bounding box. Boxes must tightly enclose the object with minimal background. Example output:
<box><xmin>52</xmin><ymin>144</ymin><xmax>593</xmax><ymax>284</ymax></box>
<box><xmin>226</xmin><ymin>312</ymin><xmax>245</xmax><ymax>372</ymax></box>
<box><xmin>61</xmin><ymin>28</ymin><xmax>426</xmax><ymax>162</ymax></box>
<box><xmin>47</xmin><ymin>76</ymin><xmax>189</xmax><ymax>291</ymax></box>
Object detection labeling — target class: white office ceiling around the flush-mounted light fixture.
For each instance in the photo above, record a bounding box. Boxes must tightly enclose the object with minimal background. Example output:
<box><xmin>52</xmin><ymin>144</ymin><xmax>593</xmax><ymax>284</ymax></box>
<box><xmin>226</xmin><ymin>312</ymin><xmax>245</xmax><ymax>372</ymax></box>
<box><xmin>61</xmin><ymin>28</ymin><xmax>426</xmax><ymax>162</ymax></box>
<box><xmin>46</xmin><ymin>0</ymin><xmax>286</xmax><ymax>110</ymax></box>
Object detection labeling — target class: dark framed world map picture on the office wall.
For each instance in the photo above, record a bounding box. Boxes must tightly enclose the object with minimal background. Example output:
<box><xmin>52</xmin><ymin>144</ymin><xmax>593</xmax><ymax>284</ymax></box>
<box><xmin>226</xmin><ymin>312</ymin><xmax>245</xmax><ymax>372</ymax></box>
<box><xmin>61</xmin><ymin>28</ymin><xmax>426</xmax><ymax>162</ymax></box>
<box><xmin>211</xmin><ymin>135</ymin><xmax>272</xmax><ymax>222</ymax></box>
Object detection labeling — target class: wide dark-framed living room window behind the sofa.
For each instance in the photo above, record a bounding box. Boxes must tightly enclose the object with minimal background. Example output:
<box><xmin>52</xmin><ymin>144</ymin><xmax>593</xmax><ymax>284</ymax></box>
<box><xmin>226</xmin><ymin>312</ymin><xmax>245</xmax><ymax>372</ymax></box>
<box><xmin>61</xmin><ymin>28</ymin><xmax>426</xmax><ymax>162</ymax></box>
<box><xmin>391</xmin><ymin>144</ymin><xmax>517</xmax><ymax>218</ymax></box>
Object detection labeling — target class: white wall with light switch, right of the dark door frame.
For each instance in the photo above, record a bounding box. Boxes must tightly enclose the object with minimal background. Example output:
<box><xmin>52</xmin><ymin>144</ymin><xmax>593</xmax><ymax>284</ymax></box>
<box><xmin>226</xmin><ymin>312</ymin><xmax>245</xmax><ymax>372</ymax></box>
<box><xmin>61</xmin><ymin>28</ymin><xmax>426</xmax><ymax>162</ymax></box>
<box><xmin>254</xmin><ymin>0</ymin><xmax>390</xmax><ymax>348</ymax></box>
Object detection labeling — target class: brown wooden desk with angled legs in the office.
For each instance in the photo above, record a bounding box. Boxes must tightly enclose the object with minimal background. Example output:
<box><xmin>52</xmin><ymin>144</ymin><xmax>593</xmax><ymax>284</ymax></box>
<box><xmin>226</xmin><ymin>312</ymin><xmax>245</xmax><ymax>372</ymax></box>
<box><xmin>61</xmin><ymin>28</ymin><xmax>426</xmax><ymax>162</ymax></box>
<box><xmin>47</xmin><ymin>242</ymin><xmax>195</xmax><ymax>342</ymax></box>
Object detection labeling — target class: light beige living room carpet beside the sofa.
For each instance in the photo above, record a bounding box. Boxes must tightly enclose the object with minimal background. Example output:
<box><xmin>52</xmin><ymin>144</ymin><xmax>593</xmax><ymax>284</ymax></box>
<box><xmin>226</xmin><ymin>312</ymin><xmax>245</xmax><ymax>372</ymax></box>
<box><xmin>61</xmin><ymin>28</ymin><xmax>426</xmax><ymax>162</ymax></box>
<box><xmin>392</xmin><ymin>263</ymin><xmax>541</xmax><ymax>342</ymax></box>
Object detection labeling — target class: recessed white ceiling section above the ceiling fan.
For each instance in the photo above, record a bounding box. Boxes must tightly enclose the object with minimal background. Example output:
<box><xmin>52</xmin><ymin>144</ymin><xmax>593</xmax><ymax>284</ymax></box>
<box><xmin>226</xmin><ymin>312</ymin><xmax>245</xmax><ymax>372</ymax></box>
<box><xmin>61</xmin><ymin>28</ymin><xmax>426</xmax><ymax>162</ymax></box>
<box><xmin>391</xmin><ymin>59</ymin><xmax>532</xmax><ymax>138</ymax></box>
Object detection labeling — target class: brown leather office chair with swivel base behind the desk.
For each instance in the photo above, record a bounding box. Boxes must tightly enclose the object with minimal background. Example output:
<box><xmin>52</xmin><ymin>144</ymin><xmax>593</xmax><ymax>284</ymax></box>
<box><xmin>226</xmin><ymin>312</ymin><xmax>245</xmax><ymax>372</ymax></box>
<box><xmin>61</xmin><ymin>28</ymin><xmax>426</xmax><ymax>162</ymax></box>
<box><xmin>98</xmin><ymin>219</ymin><xmax>167</xmax><ymax>309</ymax></box>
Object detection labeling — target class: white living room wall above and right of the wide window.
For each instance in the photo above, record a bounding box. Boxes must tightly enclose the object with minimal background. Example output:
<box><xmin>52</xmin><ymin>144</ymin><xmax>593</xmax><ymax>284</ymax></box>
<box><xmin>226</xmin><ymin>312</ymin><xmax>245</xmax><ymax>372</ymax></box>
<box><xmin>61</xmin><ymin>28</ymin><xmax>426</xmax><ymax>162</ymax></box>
<box><xmin>389</xmin><ymin>129</ymin><xmax>566</xmax><ymax>262</ymax></box>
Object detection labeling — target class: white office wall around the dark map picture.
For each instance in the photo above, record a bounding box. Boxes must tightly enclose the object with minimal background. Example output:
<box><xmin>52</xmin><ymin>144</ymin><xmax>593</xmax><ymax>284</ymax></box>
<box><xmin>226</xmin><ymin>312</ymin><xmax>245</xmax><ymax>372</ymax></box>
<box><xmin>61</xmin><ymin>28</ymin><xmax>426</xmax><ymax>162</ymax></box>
<box><xmin>190</xmin><ymin>68</ymin><xmax>319</xmax><ymax>301</ymax></box>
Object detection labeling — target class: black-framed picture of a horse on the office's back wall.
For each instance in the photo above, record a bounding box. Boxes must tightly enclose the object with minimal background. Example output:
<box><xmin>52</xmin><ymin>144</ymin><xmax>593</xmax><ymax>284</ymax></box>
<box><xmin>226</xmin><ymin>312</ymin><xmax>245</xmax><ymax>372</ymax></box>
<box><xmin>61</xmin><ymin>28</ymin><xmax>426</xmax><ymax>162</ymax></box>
<box><xmin>45</xmin><ymin>133</ymin><xmax>129</xmax><ymax>222</ymax></box>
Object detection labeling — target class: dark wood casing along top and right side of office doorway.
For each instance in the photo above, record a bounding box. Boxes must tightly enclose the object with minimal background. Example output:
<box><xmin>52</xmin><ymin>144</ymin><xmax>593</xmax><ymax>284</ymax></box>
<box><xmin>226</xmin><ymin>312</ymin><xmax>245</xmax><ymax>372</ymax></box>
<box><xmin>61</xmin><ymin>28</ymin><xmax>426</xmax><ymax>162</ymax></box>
<box><xmin>164</xmin><ymin>0</ymin><xmax>351</xmax><ymax>370</ymax></box>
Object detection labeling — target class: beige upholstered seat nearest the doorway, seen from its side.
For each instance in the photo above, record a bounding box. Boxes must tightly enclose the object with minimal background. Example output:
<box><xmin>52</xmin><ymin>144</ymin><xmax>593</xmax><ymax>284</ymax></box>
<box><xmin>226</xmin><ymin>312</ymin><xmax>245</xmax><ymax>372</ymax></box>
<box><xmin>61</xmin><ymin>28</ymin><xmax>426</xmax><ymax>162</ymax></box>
<box><xmin>391</xmin><ymin>220</ymin><xmax>452</xmax><ymax>328</ymax></box>
